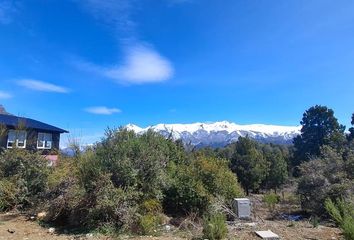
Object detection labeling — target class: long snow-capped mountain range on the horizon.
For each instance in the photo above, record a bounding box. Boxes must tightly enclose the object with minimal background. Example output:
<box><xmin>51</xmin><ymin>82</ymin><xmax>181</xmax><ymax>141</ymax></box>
<box><xmin>126</xmin><ymin>121</ymin><xmax>301</xmax><ymax>147</ymax></box>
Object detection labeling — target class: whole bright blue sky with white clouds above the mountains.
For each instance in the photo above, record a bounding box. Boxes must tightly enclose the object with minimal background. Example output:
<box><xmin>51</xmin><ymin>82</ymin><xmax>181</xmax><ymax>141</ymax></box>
<box><xmin>0</xmin><ymin>0</ymin><xmax>354</xmax><ymax>142</ymax></box>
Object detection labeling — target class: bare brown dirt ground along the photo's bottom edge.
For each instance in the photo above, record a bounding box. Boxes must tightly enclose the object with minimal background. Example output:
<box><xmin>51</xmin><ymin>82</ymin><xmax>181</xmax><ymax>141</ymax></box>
<box><xmin>0</xmin><ymin>214</ymin><xmax>342</xmax><ymax>240</ymax></box>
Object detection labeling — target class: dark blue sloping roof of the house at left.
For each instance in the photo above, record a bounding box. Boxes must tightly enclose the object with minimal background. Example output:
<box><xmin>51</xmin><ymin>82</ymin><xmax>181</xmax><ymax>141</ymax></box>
<box><xmin>0</xmin><ymin>114</ymin><xmax>68</xmax><ymax>133</ymax></box>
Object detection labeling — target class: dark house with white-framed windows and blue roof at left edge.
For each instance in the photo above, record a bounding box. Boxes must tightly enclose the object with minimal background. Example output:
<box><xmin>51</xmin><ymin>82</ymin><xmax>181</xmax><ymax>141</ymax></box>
<box><xmin>0</xmin><ymin>112</ymin><xmax>68</xmax><ymax>156</ymax></box>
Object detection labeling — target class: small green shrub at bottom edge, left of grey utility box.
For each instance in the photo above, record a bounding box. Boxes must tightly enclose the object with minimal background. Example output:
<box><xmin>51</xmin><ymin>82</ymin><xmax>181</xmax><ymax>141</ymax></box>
<box><xmin>203</xmin><ymin>213</ymin><xmax>228</xmax><ymax>240</ymax></box>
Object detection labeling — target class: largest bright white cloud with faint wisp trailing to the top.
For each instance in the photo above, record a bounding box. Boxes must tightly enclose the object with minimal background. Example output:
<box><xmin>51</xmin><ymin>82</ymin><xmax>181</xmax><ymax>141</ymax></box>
<box><xmin>76</xmin><ymin>0</ymin><xmax>174</xmax><ymax>84</ymax></box>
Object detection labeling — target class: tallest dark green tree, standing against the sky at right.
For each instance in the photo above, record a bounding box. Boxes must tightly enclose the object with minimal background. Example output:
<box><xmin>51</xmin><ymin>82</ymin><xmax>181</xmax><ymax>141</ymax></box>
<box><xmin>293</xmin><ymin>105</ymin><xmax>345</xmax><ymax>166</ymax></box>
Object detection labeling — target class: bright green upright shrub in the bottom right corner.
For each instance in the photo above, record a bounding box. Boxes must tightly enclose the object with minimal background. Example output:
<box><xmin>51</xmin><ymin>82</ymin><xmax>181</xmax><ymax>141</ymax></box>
<box><xmin>325</xmin><ymin>199</ymin><xmax>354</xmax><ymax>240</ymax></box>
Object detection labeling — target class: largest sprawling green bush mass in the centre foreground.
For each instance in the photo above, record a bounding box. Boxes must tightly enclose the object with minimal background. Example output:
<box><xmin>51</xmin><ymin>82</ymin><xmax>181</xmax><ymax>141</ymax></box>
<box><xmin>35</xmin><ymin>129</ymin><xmax>243</xmax><ymax>234</ymax></box>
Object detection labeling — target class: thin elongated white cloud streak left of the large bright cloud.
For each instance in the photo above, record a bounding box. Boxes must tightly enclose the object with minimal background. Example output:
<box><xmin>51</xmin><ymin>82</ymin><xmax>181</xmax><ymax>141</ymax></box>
<box><xmin>17</xmin><ymin>79</ymin><xmax>69</xmax><ymax>93</ymax></box>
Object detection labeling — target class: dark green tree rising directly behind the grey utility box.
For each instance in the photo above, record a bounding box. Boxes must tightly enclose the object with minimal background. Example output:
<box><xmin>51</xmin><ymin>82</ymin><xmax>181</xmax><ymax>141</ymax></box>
<box><xmin>231</xmin><ymin>137</ymin><xmax>268</xmax><ymax>195</ymax></box>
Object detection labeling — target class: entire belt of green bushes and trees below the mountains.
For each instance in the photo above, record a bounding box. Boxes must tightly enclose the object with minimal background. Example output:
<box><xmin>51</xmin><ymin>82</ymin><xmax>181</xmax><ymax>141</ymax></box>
<box><xmin>0</xmin><ymin>106</ymin><xmax>354</xmax><ymax>239</ymax></box>
